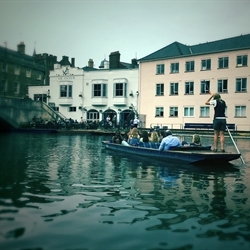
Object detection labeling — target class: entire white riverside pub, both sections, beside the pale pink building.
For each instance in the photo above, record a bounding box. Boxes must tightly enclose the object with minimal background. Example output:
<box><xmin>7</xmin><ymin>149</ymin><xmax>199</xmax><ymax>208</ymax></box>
<box><xmin>29</xmin><ymin>64</ymin><xmax>139</xmax><ymax>126</ymax></box>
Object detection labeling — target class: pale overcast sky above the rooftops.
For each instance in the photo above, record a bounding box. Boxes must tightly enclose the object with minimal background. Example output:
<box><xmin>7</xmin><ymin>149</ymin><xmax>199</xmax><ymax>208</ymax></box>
<box><xmin>0</xmin><ymin>0</ymin><xmax>250</xmax><ymax>68</ymax></box>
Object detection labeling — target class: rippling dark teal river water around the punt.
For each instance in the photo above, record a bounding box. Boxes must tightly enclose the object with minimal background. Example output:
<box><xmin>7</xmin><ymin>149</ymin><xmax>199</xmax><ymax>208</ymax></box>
<box><xmin>0</xmin><ymin>135</ymin><xmax>250</xmax><ymax>249</ymax></box>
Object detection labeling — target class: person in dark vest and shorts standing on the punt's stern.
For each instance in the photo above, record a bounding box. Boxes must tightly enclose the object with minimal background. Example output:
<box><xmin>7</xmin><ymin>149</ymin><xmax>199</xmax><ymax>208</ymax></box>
<box><xmin>205</xmin><ymin>93</ymin><xmax>227</xmax><ymax>152</ymax></box>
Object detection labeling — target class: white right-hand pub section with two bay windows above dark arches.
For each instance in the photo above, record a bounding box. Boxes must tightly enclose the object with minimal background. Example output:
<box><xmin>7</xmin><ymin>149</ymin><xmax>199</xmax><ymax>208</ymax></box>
<box><xmin>79</xmin><ymin>68</ymin><xmax>139</xmax><ymax>125</ymax></box>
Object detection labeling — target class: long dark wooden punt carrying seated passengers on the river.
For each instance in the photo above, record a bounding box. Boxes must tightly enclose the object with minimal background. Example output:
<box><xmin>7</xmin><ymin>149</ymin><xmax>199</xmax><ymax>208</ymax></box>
<box><xmin>102</xmin><ymin>141</ymin><xmax>241</xmax><ymax>164</ymax></box>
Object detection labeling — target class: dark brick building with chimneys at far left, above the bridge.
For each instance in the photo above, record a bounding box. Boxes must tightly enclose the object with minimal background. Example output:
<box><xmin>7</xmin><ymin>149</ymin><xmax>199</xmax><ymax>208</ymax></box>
<box><xmin>0</xmin><ymin>42</ymin><xmax>57</xmax><ymax>98</ymax></box>
